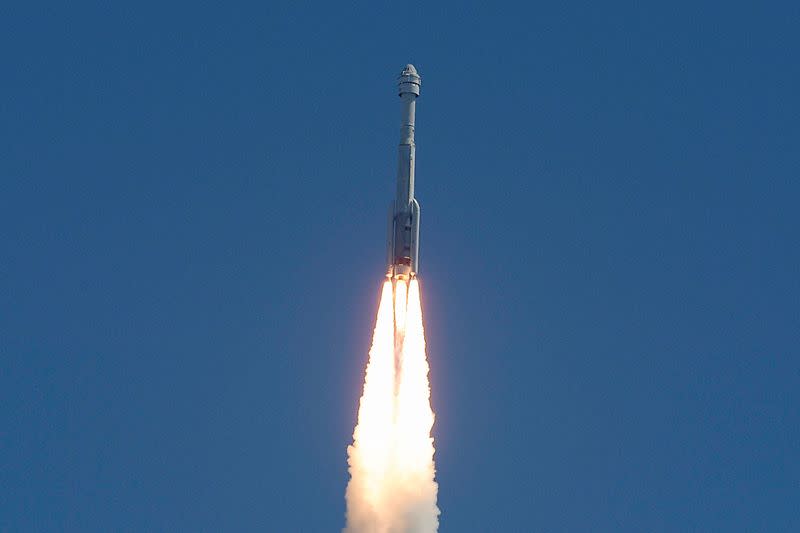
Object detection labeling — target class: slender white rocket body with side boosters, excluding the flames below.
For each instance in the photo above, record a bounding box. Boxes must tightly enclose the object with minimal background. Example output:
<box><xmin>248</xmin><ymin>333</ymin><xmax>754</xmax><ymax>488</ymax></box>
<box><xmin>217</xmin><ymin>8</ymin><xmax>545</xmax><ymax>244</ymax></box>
<box><xmin>386</xmin><ymin>65</ymin><xmax>422</xmax><ymax>279</ymax></box>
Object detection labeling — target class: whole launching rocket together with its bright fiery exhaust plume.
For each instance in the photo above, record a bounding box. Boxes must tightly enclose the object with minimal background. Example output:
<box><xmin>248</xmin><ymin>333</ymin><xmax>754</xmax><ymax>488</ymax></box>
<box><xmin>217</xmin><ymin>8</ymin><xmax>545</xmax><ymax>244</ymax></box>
<box><xmin>344</xmin><ymin>65</ymin><xmax>439</xmax><ymax>533</ymax></box>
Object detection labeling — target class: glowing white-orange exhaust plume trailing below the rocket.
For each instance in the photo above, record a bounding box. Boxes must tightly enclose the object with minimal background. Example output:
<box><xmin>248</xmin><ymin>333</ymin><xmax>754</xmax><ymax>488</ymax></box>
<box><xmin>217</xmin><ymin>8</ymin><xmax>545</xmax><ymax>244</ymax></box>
<box><xmin>344</xmin><ymin>280</ymin><xmax>439</xmax><ymax>533</ymax></box>
